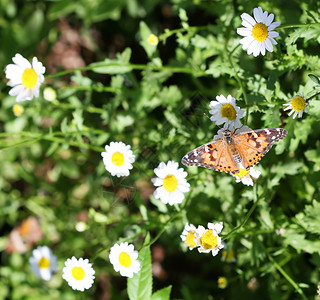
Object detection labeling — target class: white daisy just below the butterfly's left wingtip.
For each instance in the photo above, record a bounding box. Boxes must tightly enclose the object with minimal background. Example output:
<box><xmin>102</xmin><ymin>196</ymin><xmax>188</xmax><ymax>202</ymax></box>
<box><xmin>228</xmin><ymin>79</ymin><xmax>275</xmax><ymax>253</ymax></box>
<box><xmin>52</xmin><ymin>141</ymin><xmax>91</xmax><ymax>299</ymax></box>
<box><xmin>151</xmin><ymin>160</ymin><xmax>190</xmax><ymax>205</ymax></box>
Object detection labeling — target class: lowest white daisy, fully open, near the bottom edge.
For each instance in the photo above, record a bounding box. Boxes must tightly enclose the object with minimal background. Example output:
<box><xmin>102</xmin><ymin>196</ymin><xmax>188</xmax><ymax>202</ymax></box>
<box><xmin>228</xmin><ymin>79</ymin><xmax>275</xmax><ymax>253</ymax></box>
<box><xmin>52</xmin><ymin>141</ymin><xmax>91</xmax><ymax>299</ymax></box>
<box><xmin>62</xmin><ymin>256</ymin><xmax>95</xmax><ymax>292</ymax></box>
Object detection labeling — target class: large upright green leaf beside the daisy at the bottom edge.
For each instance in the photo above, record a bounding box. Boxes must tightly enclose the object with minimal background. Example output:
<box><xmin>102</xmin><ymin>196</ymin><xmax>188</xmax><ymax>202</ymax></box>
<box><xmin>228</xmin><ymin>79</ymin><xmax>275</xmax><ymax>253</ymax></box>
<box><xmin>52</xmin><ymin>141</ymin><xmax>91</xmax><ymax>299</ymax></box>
<box><xmin>127</xmin><ymin>247</ymin><xmax>152</xmax><ymax>300</ymax></box>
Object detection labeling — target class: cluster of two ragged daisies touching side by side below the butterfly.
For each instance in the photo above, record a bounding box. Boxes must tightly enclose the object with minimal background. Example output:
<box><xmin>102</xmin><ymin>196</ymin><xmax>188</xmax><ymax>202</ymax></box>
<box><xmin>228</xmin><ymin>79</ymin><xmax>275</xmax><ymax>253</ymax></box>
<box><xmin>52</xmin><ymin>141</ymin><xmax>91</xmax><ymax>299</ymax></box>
<box><xmin>180</xmin><ymin>222</ymin><xmax>224</xmax><ymax>256</ymax></box>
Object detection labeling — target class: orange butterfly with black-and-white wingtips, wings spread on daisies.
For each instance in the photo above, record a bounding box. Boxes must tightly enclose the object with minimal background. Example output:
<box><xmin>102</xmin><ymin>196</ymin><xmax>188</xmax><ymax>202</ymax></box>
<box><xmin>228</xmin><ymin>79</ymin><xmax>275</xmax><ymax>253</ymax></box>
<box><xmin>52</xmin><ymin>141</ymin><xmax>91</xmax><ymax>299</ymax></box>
<box><xmin>181</xmin><ymin>128</ymin><xmax>288</xmax><ymax>174</ymax></box>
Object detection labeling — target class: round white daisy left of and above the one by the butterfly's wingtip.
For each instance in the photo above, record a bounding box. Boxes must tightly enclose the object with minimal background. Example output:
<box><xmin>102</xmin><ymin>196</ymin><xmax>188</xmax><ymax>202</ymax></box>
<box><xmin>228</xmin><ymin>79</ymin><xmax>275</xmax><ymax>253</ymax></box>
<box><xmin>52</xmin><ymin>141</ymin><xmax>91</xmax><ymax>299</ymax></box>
<box><xmin>101</xmin><ymin>142</ymin><xmax>135</xmax><ymax>177</ymax></box>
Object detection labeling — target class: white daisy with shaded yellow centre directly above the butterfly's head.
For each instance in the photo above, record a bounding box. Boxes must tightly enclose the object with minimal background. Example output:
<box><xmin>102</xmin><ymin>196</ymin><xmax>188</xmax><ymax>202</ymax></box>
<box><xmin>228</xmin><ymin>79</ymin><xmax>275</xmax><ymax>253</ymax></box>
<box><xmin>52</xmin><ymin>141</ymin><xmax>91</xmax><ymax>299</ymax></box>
<box><xmin>209</xmin><ymin>95</ymin><xmax>244</xmax><ymax>128</ymax></box>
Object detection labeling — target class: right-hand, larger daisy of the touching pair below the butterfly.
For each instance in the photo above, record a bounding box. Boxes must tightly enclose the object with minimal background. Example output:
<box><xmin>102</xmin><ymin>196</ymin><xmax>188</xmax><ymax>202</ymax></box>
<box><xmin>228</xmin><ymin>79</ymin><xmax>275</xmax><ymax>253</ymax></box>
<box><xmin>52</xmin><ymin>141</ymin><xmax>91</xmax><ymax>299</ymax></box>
<box><xmin>196</xmin><ymin>222</ymin><xmax>223</xmax><ymax>256</ymax></box>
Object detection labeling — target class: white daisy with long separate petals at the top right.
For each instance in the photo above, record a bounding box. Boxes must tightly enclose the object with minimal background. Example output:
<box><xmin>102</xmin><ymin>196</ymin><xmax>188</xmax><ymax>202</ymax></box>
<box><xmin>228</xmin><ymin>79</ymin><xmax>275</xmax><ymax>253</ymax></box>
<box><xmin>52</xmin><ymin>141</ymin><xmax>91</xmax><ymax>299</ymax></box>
<box><xmin>237</xmin><ymin>6</ymin><xmax>280</xmax><ymax>56</ymax></box>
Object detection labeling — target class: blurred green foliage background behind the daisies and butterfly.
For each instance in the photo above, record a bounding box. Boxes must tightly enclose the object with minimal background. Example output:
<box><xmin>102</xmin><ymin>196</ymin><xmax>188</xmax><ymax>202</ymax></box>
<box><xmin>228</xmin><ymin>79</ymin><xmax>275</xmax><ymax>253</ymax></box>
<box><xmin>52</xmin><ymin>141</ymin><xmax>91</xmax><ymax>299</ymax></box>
<box><xmin>0</xmin><ymin>0</ymin><xmax>320</xmax><ymax>299</ymax></box>
